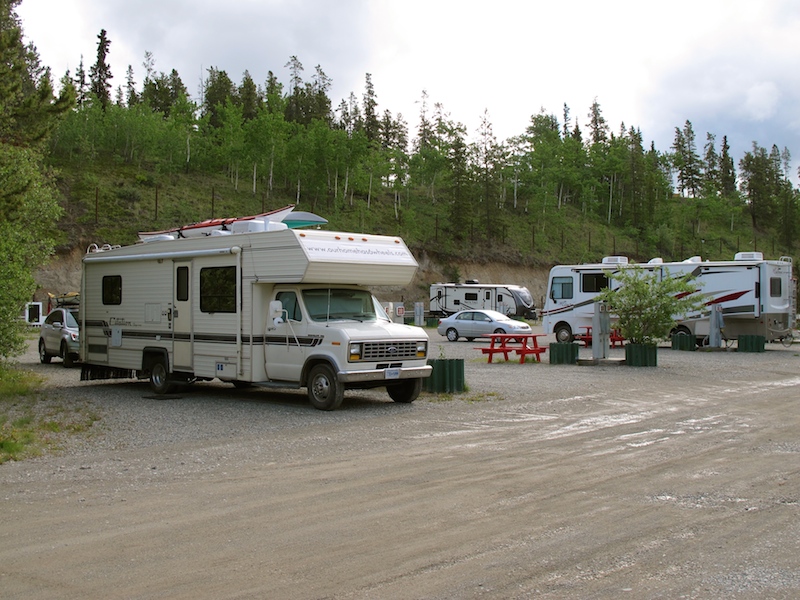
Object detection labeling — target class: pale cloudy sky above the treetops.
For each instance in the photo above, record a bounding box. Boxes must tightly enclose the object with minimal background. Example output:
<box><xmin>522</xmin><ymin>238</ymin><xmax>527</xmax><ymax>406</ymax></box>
<box><xmin>18</xmin><ymin>0</ymin><xmax>800</xmax><ymax>175</ymax></box>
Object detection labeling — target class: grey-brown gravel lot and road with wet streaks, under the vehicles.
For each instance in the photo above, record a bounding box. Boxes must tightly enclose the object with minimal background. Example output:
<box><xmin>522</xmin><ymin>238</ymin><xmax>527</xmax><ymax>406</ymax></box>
<box><xmin>0</xmin><ymin>331</ymin><xmax>800</xmax><ymax>600</ymax></box>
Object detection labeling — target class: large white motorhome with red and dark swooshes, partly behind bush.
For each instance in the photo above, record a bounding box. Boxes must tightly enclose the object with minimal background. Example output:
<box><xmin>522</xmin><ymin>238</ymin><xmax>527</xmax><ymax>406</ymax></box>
<box><xmin>542</xmin><ymin>252</ymin><xmax>796</xmax><ymax>344</ymax></box>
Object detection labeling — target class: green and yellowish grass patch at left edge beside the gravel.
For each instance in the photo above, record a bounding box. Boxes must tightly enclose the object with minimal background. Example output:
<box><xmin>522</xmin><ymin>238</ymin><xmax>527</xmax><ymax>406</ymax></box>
<box><xmin>0</xmin><ymin>363</ymin><xmax>100</xmax><ymax>464</ymax></box>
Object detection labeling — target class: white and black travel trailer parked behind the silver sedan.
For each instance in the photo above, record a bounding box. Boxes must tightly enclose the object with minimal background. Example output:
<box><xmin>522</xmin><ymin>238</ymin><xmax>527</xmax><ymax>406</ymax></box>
<box><xmin>430</xmin><ymin>280</ymin><xmax>536</xmax><ymax>319</ymax></box>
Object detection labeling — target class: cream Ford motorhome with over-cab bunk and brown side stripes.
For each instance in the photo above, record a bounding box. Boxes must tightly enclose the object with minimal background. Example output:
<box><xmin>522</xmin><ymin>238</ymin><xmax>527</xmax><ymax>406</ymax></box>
<box><xmin>80</xmin><ymin>219</ymin><xmax>431</xmax><ymax>410</ymax></box>
